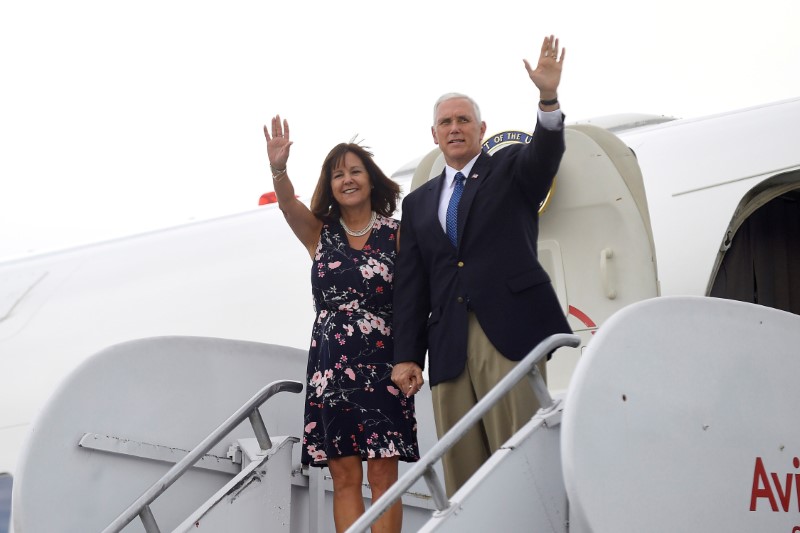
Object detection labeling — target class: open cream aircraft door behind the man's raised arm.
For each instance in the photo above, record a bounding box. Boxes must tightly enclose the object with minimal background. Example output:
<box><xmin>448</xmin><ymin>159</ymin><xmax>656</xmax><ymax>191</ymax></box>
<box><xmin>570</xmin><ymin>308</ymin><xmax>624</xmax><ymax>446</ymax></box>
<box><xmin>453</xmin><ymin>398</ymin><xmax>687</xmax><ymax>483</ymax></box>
<box><xmin>539</xmin><ymin>125</ymin><xmax>659</xmax><ymax>391</ymax></box>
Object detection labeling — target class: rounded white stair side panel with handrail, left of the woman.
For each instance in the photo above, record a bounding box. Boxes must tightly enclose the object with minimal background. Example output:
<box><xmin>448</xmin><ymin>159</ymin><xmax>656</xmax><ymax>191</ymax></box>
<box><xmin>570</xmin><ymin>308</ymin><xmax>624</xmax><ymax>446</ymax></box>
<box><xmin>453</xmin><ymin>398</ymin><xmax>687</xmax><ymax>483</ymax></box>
<box><xmin>13</xmin><ymin>337</ymin><xmax>433</xmax><ymax>533</ymax></box>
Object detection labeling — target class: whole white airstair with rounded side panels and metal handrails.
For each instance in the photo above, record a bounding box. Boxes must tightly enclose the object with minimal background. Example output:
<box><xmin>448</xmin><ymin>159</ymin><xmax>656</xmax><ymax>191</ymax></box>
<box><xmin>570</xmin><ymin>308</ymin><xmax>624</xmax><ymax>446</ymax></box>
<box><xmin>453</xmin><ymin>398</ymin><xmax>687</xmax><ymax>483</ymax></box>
<box><xmin>14</xmin><ymin>297</ymin><xmax>800</xmax><ymax>533</ymax></box>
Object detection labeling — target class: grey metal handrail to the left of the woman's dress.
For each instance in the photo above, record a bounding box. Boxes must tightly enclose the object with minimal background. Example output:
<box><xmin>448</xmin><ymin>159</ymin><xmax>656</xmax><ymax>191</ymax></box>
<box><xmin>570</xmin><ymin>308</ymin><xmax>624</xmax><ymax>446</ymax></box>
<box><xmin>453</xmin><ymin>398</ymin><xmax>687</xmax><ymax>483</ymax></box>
<box><xmin>98</xmin><ymin>380</ymin><xmax>303</xmax><ymax>533</ymax></box>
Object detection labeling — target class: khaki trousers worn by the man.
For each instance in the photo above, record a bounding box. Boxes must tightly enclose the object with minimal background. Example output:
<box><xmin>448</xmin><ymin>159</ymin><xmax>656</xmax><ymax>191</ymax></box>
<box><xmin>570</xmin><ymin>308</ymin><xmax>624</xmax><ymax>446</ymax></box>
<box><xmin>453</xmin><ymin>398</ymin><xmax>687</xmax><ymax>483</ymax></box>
<box><xmin>431</xmin><ymin>313</ymin><xmax>547</xmax><ymax>497</ymax></box>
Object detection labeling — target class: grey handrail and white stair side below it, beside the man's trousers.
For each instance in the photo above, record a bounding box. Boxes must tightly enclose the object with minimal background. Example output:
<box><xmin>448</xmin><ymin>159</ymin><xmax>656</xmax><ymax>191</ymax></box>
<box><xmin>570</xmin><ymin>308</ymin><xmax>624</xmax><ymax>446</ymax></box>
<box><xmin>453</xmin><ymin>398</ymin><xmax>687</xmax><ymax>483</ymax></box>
<box><xmin>347</xmin><ymin>334</ymin><xmax>580</xmax><ymax>533</ymax></box>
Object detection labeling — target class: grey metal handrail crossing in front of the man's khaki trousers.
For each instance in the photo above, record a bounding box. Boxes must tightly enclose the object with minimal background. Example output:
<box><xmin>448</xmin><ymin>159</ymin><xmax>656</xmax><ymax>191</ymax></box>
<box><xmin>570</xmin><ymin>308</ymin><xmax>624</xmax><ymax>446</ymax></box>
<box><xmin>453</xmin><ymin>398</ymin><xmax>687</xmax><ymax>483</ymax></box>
<box><xmin>345</xmin><ymin>333</ymin><xmax>581</xmax><ymax>533</ymax></box>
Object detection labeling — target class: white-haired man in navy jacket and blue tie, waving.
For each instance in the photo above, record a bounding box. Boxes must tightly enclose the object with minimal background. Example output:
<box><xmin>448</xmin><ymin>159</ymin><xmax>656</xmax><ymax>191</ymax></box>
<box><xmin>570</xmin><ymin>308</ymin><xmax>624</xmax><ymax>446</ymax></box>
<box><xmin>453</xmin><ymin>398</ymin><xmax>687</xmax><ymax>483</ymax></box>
<box><xmin>392</xmin><ymin>35</ymin><xmax>571</xmax><ymax>496</ymax></box>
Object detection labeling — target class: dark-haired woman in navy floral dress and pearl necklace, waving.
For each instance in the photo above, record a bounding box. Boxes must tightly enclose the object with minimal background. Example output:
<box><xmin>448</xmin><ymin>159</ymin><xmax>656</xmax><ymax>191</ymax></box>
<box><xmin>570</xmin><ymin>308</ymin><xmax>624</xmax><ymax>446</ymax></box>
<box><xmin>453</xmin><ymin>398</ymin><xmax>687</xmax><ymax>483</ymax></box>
<box><xmin>264</xmin><ymin>115</ymin><xmax>419</xmax><ymax>532</ymax></box>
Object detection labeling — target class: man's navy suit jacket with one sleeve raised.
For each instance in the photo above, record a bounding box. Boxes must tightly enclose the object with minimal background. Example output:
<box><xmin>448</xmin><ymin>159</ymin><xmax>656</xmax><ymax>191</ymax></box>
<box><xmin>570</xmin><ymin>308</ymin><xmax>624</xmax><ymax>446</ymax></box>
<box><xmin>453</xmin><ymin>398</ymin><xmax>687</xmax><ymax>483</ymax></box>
<box><xmin>393</xmin><ymin>124</ymin><xmax>571</xmax><ymax>386</ymax></box>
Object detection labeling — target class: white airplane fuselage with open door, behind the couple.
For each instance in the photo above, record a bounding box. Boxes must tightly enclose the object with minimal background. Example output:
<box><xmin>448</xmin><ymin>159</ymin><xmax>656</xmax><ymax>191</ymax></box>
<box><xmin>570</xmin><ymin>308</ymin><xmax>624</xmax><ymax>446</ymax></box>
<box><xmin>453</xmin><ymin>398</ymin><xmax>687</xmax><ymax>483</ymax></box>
<box><xmin>0</xmin><ymin>99</ymin><xmax>800</xmax><ymax>528</ymax></box>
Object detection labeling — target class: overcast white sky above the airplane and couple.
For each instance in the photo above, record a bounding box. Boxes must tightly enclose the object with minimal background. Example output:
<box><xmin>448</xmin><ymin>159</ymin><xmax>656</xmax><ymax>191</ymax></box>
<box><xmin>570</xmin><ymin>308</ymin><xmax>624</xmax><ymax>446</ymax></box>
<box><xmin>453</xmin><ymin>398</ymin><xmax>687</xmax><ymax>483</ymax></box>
<box><xmin>0</xmin><ymin>0</ymin><xmax>800</xmax><ymax>260</ymax></box>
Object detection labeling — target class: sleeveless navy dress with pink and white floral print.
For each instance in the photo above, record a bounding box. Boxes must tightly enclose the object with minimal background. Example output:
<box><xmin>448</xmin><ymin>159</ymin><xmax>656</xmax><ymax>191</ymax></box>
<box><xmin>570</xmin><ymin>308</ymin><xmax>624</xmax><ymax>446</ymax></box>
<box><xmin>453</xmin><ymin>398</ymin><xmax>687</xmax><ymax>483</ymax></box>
<box><xmin>302</xmin><ymin>216</ymin><xmax>419</xmax><ymax>466</ymax></box>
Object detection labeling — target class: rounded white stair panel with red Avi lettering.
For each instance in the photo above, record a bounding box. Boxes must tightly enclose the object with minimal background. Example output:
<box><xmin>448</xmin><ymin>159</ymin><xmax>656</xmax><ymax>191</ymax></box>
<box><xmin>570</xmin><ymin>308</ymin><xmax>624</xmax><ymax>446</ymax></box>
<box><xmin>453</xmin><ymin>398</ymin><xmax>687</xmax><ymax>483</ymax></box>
<box><xmin>561</xmin><ymin>297</ymin><xmax>800</xmax><ymax>533</ymax></box>
